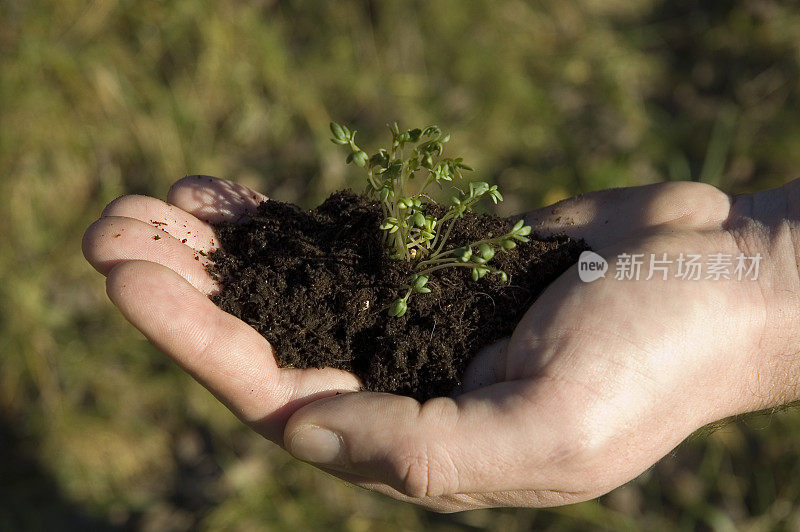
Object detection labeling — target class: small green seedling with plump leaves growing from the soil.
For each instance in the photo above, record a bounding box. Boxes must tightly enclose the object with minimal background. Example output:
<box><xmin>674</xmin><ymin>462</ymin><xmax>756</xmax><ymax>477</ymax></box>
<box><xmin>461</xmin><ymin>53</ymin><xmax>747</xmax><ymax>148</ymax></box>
<box><xmin>331</xmin><ymin>122</ymin><xmax>531</xmax><ymax>317</ymax></box>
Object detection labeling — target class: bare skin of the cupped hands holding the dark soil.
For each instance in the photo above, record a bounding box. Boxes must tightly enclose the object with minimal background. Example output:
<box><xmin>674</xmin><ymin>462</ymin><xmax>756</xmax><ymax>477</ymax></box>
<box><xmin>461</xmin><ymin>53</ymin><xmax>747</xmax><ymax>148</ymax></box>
<box><xmin>83</xmin><ymin>176</ymin><xmax>800</xmax><ymax>511</ymax></box>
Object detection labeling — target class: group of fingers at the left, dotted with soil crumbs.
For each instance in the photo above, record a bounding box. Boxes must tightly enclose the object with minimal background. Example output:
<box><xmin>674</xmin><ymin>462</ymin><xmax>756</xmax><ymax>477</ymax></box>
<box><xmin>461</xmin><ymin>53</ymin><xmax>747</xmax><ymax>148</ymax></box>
<box><xmin>83</xmin><ymin>176</ymin><xmax>359</xmax><ymax>444</ymax></box>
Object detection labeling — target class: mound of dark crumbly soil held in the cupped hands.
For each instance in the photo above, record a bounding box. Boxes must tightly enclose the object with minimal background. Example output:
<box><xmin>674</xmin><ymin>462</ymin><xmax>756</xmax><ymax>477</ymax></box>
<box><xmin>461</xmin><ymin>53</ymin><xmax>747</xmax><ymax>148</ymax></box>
<box><xmin>209</xmin><ymin>191</ymin><xmax>588</xmax><ymax>400</ymax></box>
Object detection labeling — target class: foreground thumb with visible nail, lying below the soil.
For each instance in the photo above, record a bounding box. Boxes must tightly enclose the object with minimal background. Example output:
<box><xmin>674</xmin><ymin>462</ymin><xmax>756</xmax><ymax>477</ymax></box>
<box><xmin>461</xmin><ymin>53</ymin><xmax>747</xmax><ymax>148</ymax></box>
<box><xmin>284</xmin><ymin>381</ymin><xmax>568</xmax><ymax>497</ymax></box>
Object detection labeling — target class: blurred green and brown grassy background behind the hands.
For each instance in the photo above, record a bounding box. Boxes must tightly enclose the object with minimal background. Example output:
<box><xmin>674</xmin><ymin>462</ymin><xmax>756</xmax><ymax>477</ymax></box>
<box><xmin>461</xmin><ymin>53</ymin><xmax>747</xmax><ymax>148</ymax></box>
<box><xmin>0</xmin><ymin>0</ymin><xmax>800</xmax><ymax>531</ymax></box>
